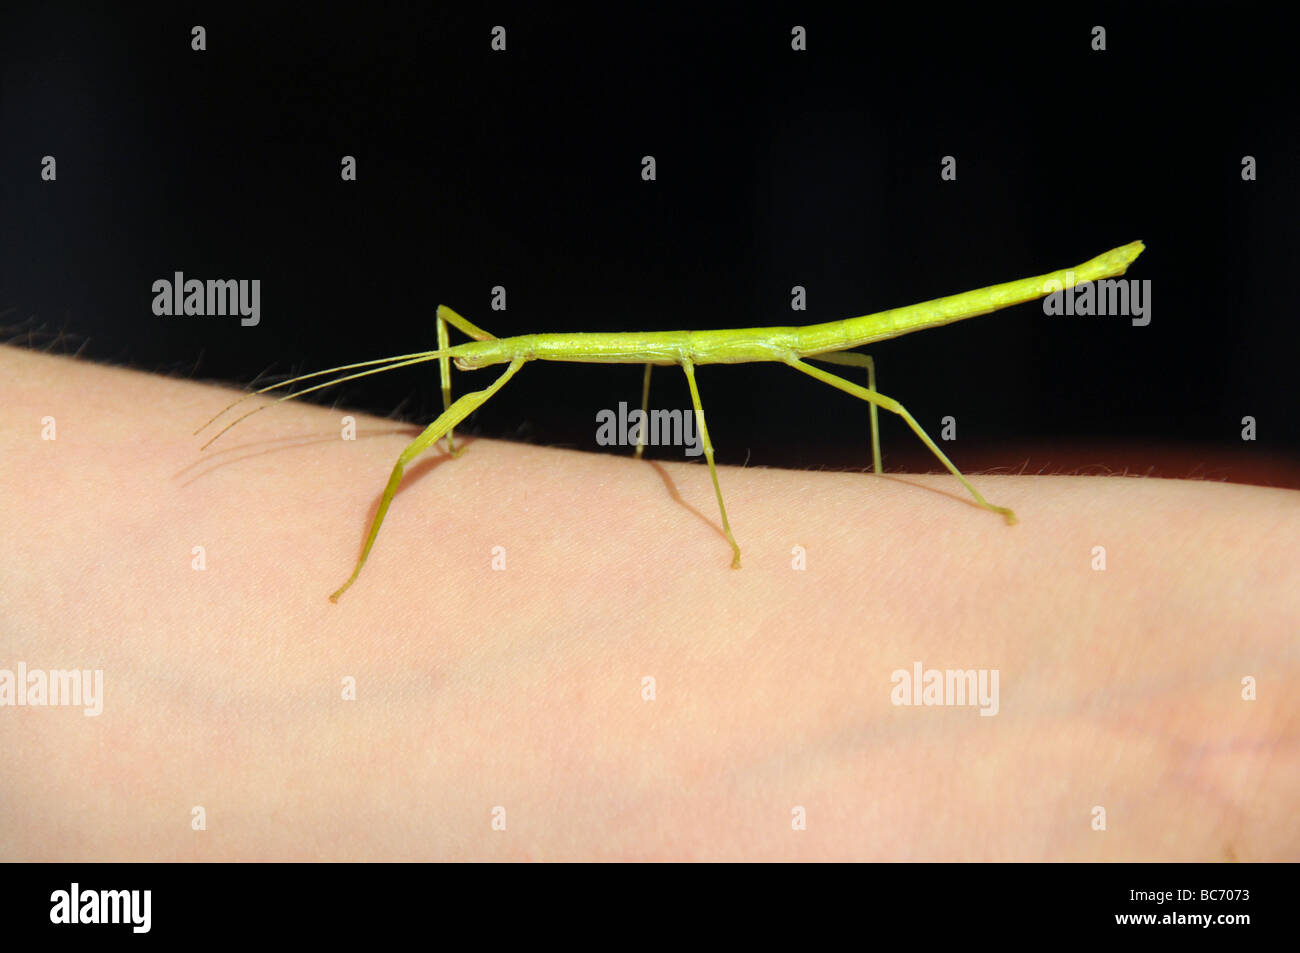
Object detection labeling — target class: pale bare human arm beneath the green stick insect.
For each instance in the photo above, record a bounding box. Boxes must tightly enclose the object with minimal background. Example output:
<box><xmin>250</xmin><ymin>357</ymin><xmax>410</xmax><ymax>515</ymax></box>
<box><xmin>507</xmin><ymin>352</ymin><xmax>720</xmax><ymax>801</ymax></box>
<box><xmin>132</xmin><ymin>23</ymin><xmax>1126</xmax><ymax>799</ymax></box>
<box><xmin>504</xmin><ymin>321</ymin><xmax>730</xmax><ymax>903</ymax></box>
<box><xmin>0</xmin><ymin>347</ymin><xmax>1300</xmax><ymax>861</ymax></box>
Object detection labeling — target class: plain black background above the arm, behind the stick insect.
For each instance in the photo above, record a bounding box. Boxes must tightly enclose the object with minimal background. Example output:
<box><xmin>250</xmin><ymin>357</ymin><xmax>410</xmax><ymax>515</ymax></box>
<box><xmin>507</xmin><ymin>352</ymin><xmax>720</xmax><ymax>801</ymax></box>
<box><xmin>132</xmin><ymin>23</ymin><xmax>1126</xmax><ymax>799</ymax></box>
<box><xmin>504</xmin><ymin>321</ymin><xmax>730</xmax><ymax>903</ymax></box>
<box><xmin>0</xmin><ymin>3</ymin><xmax>1300</xmax><ymax>486</ymax></box>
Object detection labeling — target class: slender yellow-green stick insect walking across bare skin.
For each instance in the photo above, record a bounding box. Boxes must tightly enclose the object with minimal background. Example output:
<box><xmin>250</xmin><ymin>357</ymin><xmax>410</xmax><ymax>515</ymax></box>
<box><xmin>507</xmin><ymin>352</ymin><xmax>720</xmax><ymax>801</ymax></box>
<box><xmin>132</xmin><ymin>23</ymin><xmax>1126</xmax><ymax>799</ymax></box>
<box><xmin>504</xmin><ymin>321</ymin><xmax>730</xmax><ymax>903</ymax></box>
<box><xmin>195</xmin><ymin>242</ymin><xmax>1144</xmax><ymax>602</ymax></box>
